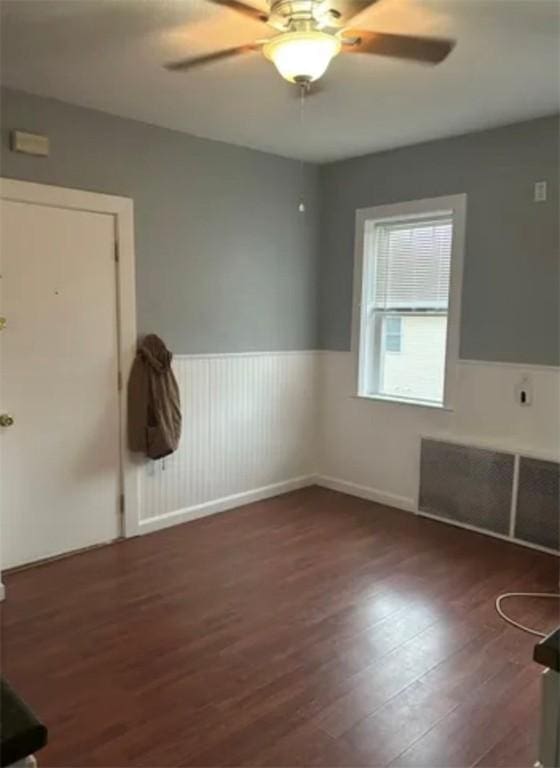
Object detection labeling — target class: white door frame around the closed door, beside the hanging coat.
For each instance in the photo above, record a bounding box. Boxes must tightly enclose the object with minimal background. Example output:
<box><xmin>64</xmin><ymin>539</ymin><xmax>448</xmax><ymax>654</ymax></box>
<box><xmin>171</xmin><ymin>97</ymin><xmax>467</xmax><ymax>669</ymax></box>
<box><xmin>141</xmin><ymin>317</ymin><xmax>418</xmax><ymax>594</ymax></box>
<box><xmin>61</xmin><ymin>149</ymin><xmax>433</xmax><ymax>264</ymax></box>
<box><xmin>0</xmin><ymin>177</ymin><xmax>140</xmax><ymax>544</ymax></box>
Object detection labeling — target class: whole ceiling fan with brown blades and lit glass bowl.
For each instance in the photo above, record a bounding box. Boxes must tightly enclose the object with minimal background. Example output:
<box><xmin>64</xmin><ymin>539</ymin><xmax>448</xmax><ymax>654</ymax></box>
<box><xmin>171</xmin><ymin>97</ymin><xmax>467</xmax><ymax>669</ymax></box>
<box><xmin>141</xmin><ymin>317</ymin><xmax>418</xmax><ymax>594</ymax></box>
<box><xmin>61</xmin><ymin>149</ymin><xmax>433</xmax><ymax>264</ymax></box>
<box><xmin>166</xmin><ymin>0</ymin><xmax>455</xmax><ymax>88</ymax></box>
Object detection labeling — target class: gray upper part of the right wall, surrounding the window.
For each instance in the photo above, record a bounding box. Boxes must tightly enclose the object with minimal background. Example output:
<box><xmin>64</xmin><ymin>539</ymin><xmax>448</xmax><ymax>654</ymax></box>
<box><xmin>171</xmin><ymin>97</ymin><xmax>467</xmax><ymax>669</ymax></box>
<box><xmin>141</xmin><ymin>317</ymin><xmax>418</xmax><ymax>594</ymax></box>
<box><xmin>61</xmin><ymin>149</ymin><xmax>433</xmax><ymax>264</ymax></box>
<box><xmin>319</xmin><ymin>117</ymin><xmax>560</xmax><ymax>365</ymax></box>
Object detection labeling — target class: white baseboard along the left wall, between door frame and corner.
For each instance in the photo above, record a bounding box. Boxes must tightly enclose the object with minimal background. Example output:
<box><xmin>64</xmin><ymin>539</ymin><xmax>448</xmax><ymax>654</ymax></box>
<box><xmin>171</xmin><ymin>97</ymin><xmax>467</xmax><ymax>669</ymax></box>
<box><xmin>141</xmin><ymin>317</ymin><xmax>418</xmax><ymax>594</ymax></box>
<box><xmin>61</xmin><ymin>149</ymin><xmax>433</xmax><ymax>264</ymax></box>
<box><xmin>139</xmin><ymin>475</ymin><xmax>315</xmax><ymax>534</ymax></box>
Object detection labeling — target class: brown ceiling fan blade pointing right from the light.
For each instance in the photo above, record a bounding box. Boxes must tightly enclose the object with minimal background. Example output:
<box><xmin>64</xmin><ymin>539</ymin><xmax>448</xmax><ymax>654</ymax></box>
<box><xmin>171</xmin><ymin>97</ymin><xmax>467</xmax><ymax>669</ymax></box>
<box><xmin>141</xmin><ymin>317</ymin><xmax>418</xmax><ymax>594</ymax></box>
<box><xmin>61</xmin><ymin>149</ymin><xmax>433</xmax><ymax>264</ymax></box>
<box><xmin>342</xmin><ymin>29</ymin><xmax>455</xmax><ymax>64</ymax></box>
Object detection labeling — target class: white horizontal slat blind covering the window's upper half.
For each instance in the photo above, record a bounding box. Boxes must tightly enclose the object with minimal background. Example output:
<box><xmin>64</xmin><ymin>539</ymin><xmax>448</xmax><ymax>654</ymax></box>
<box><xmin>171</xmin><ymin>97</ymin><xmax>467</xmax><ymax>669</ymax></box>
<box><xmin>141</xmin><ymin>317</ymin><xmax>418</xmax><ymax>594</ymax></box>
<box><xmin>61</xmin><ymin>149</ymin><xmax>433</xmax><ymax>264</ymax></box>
<box><xmin>373</xmin><ymin>215</ymin><xmax>453</xmax><ymax>311</ymax></box>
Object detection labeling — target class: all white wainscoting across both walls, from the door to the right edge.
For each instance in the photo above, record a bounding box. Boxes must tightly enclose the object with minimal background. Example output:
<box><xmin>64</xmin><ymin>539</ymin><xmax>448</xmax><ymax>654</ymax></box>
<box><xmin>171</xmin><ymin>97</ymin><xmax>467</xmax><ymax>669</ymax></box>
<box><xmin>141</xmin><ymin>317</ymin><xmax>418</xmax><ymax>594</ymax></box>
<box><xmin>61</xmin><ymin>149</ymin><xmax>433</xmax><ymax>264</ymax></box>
<box><xmin>139</xmin><ymin>351</ymin><xmax>560</xmax><ymax>533</ymax></box>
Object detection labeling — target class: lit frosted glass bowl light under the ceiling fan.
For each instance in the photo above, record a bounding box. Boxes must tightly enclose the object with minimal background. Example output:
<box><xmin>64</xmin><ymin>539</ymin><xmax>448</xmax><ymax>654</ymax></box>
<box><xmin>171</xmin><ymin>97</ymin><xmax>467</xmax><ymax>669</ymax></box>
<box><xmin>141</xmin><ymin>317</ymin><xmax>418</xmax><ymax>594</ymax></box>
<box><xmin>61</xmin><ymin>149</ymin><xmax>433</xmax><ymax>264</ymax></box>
<box><xmin>263</xmin><ymin>30</ymin><xmax>341</xmax><ymax>83</ymax></box>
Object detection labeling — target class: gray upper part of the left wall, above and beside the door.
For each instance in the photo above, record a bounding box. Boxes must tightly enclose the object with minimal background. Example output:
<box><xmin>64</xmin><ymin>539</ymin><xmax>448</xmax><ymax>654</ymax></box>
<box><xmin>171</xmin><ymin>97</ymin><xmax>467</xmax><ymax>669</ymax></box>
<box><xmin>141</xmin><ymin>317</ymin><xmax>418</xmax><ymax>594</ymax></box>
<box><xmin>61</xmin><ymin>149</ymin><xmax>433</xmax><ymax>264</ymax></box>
<box><xmin>1</xmin><ymin>89</ymin><xmax>318</xmax><ymax>353</ymax></box>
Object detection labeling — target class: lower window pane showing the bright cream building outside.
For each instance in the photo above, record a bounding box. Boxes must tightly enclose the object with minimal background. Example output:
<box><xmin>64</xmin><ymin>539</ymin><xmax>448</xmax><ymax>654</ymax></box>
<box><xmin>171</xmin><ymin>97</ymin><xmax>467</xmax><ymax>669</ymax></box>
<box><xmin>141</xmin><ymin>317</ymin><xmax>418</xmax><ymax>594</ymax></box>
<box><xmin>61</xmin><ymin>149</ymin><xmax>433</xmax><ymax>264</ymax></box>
<box><xmin>373</xmin><ymin>315</ymin><xmax>447</xmax><ymax>402</ymax></box>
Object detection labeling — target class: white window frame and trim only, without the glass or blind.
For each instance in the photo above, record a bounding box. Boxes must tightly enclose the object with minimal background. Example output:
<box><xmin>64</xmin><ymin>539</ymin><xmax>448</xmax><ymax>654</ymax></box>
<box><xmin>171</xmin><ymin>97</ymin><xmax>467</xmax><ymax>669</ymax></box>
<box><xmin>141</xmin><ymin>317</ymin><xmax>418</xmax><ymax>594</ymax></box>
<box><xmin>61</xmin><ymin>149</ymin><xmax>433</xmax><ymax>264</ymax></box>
<box><xmin>352</xmin><ymin>194</ymin><xmax>467</xmax><ymax>410</ymax></box>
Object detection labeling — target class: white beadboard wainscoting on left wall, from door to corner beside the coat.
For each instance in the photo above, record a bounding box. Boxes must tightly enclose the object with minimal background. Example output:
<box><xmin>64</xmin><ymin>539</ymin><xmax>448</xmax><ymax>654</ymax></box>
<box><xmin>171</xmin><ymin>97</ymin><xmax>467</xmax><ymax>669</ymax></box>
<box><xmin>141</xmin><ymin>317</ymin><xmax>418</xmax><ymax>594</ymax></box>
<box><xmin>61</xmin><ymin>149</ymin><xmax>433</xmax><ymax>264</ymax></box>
<box><xmin>139</xmin><ymin>352</ymin><xmax>317</xmax><ymax>533</ymax></box>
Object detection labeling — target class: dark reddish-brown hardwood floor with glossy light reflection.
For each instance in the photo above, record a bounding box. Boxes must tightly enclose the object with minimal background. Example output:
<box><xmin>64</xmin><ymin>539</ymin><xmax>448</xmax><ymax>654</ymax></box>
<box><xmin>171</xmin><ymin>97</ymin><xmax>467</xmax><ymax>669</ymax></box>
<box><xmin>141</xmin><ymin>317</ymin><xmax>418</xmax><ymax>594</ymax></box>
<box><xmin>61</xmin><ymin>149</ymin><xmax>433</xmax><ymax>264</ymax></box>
<box><xmin>3</xmin><ymin>488</ymin><xmax>558</xmax><ymax>768</ymax></box>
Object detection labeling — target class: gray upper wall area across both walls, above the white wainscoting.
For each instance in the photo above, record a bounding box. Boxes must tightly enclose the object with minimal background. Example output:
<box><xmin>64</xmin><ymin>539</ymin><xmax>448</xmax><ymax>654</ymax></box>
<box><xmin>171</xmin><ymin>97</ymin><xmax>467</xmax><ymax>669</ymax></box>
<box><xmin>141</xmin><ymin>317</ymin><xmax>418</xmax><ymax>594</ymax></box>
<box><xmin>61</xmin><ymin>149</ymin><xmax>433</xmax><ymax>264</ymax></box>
<box><xmin>0</xmin><ymin>89</ymin><xmax>560</xmax><ymax>365</ymax></box>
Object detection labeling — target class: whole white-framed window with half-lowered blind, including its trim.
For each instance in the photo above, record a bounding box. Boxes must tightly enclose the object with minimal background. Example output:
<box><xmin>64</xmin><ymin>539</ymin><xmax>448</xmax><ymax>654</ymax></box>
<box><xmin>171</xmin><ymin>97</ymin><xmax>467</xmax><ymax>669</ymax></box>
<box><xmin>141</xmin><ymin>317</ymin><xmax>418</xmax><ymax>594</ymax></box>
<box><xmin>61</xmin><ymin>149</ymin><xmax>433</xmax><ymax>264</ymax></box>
<box><xmin>355</xmin><ymin>195</ymin><xmax>465</xmax><ymax>406</ymax></box>
